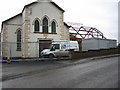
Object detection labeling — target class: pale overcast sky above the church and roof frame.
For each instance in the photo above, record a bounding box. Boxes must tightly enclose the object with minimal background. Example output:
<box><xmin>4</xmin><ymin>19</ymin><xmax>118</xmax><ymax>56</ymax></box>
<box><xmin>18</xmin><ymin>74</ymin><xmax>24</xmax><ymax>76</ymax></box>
<box><xmin>0</xmin><ymin>0</ymin><xmax>119</xmax><ymax>40</ymax></box>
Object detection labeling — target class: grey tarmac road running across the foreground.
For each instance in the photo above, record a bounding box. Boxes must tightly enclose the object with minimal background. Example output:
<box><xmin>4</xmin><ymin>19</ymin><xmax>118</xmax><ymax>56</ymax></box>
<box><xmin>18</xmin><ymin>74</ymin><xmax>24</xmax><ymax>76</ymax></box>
<box><xmin>2</xmin><ymin>57</ymin><xmax>118</xmax><ymax>88</ymax></box>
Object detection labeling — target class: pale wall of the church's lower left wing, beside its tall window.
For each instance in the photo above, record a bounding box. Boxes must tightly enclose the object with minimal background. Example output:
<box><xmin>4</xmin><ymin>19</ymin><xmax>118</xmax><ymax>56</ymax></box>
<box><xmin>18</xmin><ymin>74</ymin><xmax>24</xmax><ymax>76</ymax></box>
<box><xmin>3</xmin><ymin>15</ymin><xmax>22</xmax><ymax>57</ymax></box>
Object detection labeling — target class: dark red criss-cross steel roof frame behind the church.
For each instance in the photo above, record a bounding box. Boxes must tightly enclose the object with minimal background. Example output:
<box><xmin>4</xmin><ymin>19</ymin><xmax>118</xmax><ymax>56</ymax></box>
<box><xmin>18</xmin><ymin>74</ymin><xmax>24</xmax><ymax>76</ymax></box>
<box><xmin>68</xmin><ymin>23</ymin><xmax>106</xmax><ymax>40</ymax></box>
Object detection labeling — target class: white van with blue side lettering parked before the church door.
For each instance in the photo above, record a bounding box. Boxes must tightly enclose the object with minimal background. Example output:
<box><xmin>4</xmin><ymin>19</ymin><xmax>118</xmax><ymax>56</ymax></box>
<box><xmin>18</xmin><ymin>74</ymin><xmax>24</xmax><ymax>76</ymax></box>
<box><xmin>41</xmin><ymin>41</ymin><xmax>79</xmax><ymax>58</ymax></box>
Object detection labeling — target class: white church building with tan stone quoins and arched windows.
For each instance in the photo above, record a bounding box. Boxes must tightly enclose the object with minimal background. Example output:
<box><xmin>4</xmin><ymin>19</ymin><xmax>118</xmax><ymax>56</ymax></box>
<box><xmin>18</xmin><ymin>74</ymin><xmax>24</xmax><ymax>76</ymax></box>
<box><xmin>1</xmin><ymin>0</ymin><xmax>70</xmax><ymax>58</ymax></box>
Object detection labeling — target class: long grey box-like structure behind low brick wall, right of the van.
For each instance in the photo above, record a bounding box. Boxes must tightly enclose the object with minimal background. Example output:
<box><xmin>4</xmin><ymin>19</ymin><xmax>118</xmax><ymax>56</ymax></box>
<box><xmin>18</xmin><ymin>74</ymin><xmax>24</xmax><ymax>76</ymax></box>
<box><xmin>82</xmin><ymin>38</ymin><xmax>117</xmax><ymax>51</ymax></box>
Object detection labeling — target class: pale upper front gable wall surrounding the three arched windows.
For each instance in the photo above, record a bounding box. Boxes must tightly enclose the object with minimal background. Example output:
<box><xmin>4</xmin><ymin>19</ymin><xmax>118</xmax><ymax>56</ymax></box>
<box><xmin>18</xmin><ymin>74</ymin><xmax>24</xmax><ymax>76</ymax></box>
<box><xmin>29</xmin><ymin>2</ymin><xmax>61</xmax><ymax>41</ymax></box>
